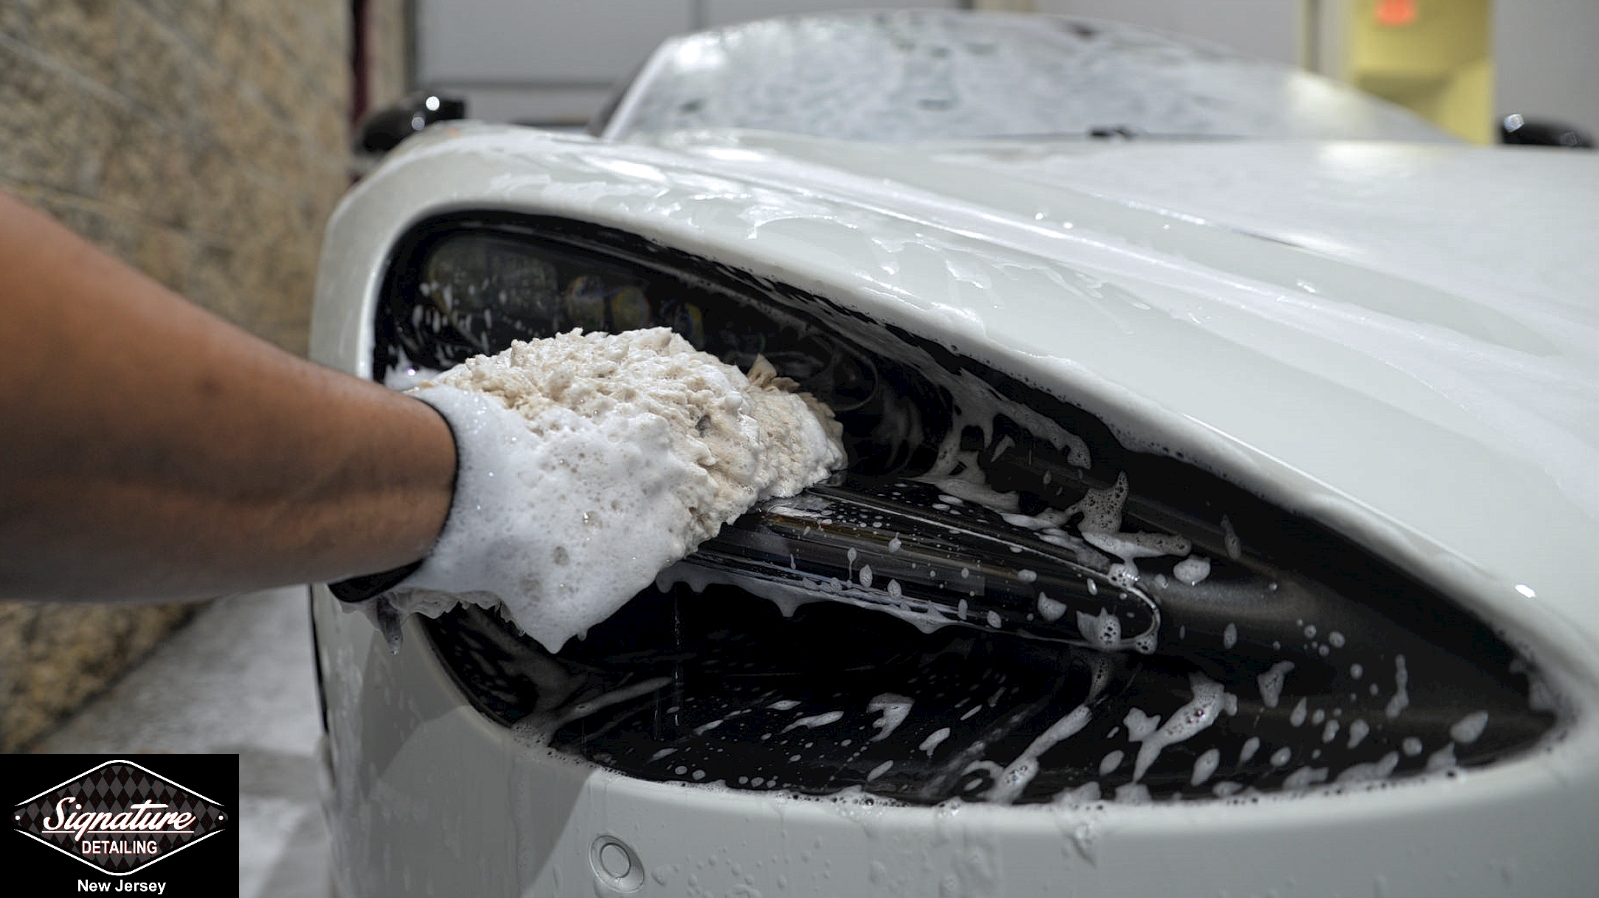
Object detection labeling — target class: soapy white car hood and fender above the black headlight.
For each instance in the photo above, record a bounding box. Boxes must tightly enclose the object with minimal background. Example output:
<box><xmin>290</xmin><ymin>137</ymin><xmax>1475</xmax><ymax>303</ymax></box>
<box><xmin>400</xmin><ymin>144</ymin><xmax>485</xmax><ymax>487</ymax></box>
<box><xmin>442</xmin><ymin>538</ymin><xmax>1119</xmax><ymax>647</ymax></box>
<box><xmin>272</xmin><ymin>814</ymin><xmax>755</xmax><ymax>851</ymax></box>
<box><xmin>313</xmin><ymin>126</ymin><xmax>1599</xmax><ymax>689</ymax></box>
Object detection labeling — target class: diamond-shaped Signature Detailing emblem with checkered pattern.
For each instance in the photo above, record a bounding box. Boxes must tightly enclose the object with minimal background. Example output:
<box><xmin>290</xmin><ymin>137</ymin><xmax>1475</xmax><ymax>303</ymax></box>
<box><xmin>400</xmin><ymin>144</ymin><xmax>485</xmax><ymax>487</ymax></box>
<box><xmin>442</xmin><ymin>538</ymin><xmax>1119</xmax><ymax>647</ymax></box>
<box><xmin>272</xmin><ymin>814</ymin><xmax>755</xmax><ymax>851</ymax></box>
<box><xmin>13</xmin><ymin>761</ymin><xmax>227</xmax><ymax>876</ymax></box>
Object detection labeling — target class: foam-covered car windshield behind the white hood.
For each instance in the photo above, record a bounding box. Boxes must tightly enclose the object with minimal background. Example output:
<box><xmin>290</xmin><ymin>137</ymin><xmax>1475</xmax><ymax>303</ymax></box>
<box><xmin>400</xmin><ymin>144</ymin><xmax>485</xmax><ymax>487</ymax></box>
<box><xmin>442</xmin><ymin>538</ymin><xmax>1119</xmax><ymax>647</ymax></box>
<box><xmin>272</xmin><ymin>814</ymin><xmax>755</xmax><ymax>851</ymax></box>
<box><xmin>593</xmin><ymin>10</ymin><xmax>1449</xmax><ymax>142</ymax></box>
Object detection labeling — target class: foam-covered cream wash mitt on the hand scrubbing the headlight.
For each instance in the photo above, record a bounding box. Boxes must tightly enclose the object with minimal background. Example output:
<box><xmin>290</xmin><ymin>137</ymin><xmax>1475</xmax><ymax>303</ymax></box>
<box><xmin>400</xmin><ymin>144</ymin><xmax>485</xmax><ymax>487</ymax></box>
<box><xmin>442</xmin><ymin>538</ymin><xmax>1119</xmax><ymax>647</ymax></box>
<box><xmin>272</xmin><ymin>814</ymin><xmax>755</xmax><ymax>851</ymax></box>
<box><xmin>375</xmin><ymin>328</ymin><xmax>844</xmax><ymax>650</ymax></box>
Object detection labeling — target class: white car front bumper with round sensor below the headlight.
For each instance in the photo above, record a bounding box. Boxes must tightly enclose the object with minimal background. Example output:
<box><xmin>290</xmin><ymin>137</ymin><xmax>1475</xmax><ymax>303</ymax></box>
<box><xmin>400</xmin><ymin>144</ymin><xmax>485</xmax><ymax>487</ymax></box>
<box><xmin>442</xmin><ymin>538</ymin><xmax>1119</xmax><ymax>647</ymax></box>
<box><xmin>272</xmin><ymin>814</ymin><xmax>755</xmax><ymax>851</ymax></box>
<box><xmin>313</xmin><ymin>588</ymin><xmax>1599</xmax><ymax>898</ymax></box>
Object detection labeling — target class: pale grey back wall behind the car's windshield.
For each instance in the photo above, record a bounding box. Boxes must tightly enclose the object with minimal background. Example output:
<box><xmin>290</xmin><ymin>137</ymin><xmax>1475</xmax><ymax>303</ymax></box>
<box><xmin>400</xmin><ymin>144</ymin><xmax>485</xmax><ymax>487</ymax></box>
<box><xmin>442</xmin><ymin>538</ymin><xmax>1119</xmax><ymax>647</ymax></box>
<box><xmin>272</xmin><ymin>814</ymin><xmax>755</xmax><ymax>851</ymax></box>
<box><xmin>414</xmin><ymin>0</ymin><xmax>1599</xmax><ymax>134</ymax></box>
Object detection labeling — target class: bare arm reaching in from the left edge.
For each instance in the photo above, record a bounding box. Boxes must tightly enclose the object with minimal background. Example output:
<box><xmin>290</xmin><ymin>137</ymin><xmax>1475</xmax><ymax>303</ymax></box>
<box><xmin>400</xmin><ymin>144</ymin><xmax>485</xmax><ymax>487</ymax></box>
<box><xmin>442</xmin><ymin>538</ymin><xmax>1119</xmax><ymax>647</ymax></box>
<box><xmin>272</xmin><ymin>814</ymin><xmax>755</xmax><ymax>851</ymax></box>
<box><xmin>0</xmin><ymin>193</ymin><xmax>456</xmax><ymax>599</ymax></box>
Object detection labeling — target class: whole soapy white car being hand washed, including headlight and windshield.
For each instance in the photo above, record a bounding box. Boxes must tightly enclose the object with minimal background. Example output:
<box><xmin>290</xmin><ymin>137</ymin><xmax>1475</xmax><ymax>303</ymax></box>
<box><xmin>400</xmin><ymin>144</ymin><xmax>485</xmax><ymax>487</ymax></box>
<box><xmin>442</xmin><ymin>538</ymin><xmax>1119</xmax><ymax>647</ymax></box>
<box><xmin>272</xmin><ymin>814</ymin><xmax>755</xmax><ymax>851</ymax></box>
<box><xmin>312</xmin><ymin>13</ymin><xmax>1599</xmax><ymax>898</ymax></box>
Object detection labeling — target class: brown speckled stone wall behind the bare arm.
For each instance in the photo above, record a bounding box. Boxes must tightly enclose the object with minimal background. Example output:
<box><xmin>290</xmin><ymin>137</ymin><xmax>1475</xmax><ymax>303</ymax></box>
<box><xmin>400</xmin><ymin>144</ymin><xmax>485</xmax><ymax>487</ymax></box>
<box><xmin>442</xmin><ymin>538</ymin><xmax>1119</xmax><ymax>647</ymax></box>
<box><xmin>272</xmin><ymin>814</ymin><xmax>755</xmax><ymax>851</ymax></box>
<box><xmin>0</xmin><ymin>0</ymin><xmax>366</xmax><ymax>751</ymax></box>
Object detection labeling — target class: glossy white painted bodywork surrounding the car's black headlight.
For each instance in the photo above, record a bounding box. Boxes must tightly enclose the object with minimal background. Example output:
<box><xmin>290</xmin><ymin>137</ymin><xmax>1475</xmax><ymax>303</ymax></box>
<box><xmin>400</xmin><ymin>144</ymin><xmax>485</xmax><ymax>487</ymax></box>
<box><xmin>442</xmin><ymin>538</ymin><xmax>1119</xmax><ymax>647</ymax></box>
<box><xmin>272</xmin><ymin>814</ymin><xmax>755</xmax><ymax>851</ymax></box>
<box><xmin>312</xmin><ymin>125</ymin><xmax>1599</xmax><ymax>895</ymax></box>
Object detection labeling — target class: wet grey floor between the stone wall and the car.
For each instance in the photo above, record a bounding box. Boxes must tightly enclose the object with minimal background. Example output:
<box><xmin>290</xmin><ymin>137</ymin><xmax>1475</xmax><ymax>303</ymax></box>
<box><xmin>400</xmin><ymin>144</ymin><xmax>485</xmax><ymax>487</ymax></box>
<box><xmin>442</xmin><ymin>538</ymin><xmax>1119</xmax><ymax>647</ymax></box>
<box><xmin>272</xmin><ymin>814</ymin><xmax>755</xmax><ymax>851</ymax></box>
<box><xmin>35</xmin><ymin>586</ymin><xmax>331</xmax><ymax>898</ymax></box>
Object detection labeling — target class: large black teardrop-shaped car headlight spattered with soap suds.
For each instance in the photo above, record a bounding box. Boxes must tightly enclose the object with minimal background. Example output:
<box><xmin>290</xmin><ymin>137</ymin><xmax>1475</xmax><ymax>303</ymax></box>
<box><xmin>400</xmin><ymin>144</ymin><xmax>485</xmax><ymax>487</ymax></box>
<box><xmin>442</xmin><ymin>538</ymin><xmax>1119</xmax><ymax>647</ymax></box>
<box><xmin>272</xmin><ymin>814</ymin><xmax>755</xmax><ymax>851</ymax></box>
<box><xmin>374</xmin><ymin>214</ymin><xmax>1557</xmax><ymax>804</ymax></box>
